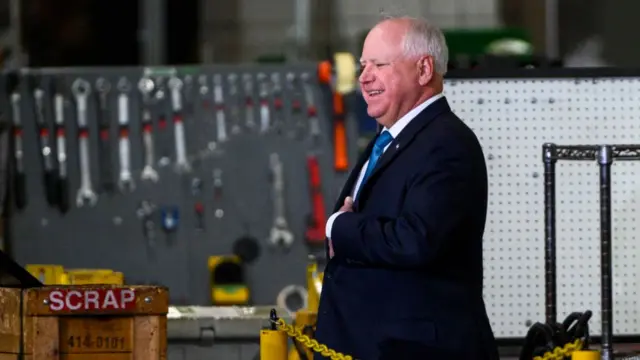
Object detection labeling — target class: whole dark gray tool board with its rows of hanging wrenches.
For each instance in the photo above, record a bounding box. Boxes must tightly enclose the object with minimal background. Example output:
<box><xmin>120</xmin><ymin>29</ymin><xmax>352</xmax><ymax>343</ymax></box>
<box><xmin>2</xmin><ymin>64</ymin><xmax>358</xmax><ymax>305</ymax></box>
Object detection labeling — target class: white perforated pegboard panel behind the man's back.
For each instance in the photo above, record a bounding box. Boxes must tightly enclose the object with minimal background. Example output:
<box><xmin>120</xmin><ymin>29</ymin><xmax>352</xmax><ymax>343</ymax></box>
<box><xmin>445</xmin><ymin>78</ymin><xmax>640</xmax><ymax>338</ymax></box>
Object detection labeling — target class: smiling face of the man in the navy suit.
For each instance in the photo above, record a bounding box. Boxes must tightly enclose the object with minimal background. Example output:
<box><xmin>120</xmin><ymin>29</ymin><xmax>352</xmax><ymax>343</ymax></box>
<box><xmin>359</xmin><ymin>21</ymin><xmax>420</xmax><ymax>127</ymax></box>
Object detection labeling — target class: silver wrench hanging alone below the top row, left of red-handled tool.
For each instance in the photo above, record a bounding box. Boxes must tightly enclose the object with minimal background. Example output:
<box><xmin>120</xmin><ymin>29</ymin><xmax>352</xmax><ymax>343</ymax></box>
<box><xmin>269</xmin><ymin>153</ymin><xmax>293</xmax><ymax>248</ymax></box>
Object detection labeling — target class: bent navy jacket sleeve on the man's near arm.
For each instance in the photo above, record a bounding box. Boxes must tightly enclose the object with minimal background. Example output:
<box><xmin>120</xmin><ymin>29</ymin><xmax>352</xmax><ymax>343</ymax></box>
<box><xmin>331</xmin><ymin>145</ymin><xmax>475</xmax><ymax>268</ymax></box>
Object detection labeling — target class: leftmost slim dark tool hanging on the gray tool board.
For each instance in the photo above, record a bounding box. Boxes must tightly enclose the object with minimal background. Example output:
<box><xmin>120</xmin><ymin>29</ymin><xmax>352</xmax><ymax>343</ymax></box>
<box><xmin>10</xmin><ymin>84</ymin><xmax>27</xmax><ymax>210</ymax></box>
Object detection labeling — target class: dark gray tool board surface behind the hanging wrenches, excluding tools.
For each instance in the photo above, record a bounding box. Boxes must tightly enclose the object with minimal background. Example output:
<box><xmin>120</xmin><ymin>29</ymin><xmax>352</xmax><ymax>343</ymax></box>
<box><xmin>3</xmin><ymin>64</ymin><xmax>357</xmax><ymax>305</ymax></box>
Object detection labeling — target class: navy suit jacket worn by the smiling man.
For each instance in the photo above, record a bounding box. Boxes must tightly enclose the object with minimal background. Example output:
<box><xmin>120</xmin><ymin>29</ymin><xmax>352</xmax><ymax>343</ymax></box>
<box><xmin>316</xmin><ymin>98</ymin><xmax>498</xmax><ymax>360</ymax></box>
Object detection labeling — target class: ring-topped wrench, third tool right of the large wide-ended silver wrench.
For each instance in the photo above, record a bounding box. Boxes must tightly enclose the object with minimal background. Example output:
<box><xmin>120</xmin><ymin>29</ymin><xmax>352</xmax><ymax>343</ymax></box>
<box><xmin>138</xmin><ymin>77</ymin><xmax>159</xmax><ymax>182</ymax></box>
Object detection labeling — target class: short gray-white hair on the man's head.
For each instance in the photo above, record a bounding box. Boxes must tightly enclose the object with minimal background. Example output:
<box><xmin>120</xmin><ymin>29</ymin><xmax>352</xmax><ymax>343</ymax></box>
<box><xmin>383</xmin><ymin>15</ymin><xmax>449</xmax><ymax>76</ymax></box>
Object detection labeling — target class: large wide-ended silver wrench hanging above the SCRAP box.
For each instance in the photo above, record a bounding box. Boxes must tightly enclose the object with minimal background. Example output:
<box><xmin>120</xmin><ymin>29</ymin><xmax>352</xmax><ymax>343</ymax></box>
<box><xmin>71</xmin><ymin>78</ymin><xmax>98</xmax><ymax>207</ymax></box>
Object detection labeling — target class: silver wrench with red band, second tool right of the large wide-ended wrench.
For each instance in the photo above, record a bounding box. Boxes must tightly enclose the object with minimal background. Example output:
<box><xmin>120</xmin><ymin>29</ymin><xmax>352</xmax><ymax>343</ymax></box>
<box><xmin>118</xmin><ymin>77</ymin><xmax>136</xmax><ymax>191</ymax></box>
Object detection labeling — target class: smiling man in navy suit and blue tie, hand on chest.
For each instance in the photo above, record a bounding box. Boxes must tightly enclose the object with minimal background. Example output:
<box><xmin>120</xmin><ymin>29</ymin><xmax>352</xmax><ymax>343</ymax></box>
<box><xmin>316</xmin><ymin>17</ymin><xmax>498</xmax><ymax>360</ymax></box>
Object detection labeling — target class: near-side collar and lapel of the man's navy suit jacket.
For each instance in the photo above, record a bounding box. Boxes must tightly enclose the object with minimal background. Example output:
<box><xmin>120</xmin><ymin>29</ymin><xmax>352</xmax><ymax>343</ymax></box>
<box><xmin>361</xmin><ymin>97</ymin><xmax>451</xmax><ymax>194</ymax></box>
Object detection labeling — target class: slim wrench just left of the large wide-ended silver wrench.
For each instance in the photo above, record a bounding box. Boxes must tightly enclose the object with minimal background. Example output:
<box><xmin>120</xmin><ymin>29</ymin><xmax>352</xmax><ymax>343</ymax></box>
<box><xmin>53</xmin><ymin>79</ymin><xmax>69</xmax><ymax>213</ymax></box>
